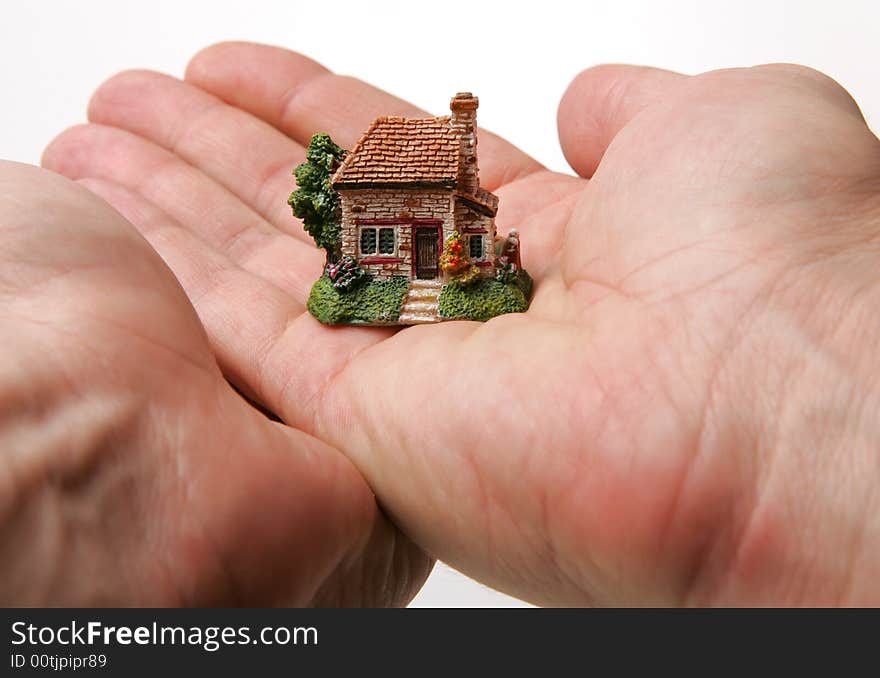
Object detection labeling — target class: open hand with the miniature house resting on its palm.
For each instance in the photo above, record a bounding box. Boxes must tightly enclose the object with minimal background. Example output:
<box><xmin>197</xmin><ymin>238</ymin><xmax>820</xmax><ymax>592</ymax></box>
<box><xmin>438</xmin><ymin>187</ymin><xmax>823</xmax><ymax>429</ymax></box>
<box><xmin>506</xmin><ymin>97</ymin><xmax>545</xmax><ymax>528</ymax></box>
<box><xmin>45</xmin><ymin>44</ymin><xmax>880</xmax><ymax>604</ymax></box>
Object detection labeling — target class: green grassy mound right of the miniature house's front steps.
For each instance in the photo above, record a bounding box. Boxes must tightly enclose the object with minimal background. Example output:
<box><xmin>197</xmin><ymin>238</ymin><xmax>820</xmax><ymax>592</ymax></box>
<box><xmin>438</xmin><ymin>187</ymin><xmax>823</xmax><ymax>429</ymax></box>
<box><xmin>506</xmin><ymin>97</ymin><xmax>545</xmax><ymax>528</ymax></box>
<box><xmin>440</xmin><ymin>271</ymin><xmax>532</xmax><ymax>320</ymax></box>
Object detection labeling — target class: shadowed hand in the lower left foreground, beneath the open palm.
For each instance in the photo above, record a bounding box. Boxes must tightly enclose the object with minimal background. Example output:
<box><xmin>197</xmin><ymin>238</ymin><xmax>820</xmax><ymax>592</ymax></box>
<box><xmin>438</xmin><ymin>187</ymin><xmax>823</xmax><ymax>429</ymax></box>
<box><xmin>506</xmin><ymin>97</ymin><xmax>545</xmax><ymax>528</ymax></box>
<box><xmin>0</xmin><ymin>163</ymin><xmax>430</xmax><ymax>606</ymax></box>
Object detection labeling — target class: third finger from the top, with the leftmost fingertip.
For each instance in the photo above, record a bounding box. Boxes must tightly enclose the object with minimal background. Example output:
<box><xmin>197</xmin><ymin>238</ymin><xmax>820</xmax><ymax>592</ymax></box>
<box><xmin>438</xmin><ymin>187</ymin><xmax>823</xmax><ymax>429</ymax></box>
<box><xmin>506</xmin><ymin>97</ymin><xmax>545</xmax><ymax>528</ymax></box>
<box><xmin>43</xmin><ymin>125</ymin><xmax>321</xmax><ymax>304</ymax></box>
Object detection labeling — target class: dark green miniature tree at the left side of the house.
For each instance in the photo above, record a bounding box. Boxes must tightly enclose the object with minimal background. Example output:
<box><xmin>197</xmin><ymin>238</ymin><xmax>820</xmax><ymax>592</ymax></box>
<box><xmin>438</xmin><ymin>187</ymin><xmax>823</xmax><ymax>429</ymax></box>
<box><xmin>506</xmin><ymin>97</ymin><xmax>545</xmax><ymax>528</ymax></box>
<box><xmin>287</xmin><ymin>134</ymin><xmax>346</xmax><ymax>262</ymax></box>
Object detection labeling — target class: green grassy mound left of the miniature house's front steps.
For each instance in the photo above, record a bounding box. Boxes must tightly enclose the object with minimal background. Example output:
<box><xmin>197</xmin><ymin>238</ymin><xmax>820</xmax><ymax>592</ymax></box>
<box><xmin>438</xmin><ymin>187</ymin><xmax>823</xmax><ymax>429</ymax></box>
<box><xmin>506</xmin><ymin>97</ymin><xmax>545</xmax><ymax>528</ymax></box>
<box><xmin>307</xmin><ymin>276</ymin><xmax>409</xmax><ymax>325</ymax></box>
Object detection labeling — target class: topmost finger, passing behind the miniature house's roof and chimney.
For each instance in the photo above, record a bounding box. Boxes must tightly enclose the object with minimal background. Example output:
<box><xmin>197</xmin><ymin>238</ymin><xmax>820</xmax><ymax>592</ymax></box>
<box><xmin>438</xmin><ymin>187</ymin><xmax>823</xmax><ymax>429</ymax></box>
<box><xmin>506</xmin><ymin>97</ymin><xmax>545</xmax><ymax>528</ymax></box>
<box><xmin>186</xmin><ymin>42</ymin><xmax>541</xmax><ymax>190</ymax></box>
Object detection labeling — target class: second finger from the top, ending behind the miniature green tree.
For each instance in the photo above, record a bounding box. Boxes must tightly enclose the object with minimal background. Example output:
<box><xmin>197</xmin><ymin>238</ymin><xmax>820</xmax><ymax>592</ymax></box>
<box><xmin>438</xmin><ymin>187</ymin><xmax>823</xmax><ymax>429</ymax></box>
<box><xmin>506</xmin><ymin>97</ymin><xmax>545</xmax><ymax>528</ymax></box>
<box><xmin>89</xmin><ymin>71</ymin><xmax>308</xmax><ymax>240</ymax></box>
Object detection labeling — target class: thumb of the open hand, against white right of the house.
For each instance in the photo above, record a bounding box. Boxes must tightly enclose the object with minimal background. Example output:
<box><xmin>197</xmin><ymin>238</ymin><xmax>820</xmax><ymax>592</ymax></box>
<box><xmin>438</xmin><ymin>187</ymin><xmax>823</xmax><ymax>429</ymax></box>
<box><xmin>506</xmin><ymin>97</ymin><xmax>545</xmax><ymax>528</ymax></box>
<box><xmin>557</xmin><ymin>65</ymin><xmax>687</xmax><ymax>177</ymax></box>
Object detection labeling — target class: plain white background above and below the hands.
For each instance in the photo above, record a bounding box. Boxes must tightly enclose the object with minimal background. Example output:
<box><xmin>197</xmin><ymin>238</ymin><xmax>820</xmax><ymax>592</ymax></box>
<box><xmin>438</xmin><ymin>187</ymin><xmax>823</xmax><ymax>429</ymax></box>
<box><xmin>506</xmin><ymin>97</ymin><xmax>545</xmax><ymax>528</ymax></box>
<box><xmin>0</xmin><ymin>0</ymin><xmax>880</xmax><ymax>606</ymax></box>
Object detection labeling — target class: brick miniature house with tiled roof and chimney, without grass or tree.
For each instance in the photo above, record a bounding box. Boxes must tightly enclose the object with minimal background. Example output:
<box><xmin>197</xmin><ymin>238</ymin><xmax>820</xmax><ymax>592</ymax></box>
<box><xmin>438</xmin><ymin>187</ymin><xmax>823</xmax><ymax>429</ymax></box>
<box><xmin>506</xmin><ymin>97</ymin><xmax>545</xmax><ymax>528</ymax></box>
<box><xmin>332</xmin><ymin>93</ymin><xmax>498</xmax><ymax>281</ymax></box>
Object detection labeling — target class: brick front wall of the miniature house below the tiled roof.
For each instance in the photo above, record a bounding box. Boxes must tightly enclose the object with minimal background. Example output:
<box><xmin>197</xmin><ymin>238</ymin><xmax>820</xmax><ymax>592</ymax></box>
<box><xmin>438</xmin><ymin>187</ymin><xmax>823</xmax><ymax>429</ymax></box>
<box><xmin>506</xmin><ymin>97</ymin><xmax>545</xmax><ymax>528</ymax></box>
<box><xmin>339</xmin><ymin>188</ymin><xmax>454</xmax><ymax>278</ymax></box>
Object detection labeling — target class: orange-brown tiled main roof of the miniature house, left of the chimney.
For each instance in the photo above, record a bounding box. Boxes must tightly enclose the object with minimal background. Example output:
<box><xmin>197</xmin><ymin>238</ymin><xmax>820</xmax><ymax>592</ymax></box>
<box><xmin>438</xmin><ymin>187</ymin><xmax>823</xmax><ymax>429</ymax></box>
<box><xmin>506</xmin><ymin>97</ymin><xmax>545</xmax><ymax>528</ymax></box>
<box><xmin>333</xmin><ymin>116</ymin><xmax>459</xmax><ymax>188</ymax></box>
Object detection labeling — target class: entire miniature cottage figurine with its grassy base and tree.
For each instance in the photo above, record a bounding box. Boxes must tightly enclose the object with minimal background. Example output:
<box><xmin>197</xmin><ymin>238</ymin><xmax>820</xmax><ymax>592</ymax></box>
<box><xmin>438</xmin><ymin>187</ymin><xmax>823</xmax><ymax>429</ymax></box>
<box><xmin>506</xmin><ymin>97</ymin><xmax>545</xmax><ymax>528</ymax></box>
<box><xmin>289</xmin><ymin>92</ymin><xmax>531</xmax><ymax>325</ymax></box>
